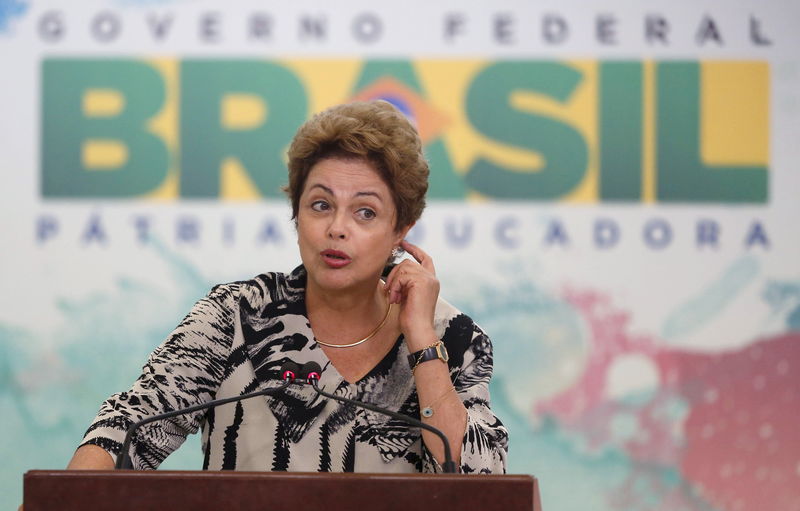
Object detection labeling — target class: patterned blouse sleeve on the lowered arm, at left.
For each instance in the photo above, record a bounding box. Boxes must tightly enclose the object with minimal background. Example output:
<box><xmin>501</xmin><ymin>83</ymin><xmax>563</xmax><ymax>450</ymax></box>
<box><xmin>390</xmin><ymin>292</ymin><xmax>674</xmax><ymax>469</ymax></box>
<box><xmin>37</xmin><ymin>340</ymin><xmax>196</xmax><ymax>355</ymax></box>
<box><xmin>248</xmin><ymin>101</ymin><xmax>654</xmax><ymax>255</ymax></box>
<box><xmin>81</xmin><ymin>284</ymin><xmax>237</xmax><ymax>469</ymax></box>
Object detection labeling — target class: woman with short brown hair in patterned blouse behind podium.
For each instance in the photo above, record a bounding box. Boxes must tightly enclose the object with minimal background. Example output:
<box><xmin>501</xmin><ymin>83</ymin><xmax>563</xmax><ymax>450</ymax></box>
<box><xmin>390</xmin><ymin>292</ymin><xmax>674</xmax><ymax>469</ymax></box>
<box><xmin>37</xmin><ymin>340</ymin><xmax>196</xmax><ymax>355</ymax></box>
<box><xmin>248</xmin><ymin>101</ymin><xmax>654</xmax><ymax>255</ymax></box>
<box><xmin>69</xmin><ymin>101</ymin><xmax>508</xmax><ymax>473</ymax></box>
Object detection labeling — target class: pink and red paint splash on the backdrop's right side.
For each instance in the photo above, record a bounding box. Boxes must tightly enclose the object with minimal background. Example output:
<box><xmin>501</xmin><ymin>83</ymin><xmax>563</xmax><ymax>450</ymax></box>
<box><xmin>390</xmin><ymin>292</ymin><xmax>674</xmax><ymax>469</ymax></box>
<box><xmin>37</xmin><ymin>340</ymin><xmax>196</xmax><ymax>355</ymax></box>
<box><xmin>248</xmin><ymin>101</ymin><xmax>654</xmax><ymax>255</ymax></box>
<box><xmin>535</xmin><ymin>290</ymin><xmax>800</xmax><ymax>511</ymax></box>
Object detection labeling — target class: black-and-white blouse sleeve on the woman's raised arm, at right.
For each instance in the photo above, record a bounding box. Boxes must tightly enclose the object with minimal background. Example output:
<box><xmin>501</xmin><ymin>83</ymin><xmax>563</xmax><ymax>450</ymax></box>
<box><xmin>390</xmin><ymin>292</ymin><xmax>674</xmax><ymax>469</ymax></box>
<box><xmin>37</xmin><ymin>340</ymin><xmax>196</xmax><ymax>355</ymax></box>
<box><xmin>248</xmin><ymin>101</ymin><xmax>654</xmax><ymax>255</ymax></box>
<box><xmin>423</xmin><ymin>315</ymin><xmax>508</xmax><ymax>474</ymax></box>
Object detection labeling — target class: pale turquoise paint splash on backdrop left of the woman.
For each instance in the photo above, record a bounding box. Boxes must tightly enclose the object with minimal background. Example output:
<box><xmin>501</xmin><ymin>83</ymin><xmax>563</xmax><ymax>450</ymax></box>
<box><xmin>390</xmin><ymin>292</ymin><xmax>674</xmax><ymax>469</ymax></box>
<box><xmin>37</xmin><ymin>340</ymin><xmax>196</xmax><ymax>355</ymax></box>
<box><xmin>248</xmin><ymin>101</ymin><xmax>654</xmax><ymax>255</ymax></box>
<box><xmin>0</xmin><ymin>238</ymin><xmax>212</xmax><ymax>508</ymax></box>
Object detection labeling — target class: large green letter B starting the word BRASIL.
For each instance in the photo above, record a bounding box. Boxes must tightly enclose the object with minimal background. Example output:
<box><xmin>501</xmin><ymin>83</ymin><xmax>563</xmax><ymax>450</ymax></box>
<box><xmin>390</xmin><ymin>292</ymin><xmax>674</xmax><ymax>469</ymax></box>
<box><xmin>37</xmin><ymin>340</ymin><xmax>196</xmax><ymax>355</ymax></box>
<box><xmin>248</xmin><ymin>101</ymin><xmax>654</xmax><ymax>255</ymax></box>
<box><xmin>41</xmin><ymin>59</ymin><xmax>169</xmax><ymax>198</ymax></box>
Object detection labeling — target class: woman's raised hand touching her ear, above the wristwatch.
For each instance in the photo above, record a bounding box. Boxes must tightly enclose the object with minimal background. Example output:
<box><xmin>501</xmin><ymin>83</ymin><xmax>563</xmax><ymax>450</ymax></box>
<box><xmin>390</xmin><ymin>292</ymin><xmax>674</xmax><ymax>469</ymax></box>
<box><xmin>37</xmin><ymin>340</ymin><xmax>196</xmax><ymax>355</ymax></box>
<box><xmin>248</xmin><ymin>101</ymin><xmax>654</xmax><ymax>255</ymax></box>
<box><xmin>386</xmin><ymin>240</ymin><xmax>439</xmax><ymax>351</ymax></box>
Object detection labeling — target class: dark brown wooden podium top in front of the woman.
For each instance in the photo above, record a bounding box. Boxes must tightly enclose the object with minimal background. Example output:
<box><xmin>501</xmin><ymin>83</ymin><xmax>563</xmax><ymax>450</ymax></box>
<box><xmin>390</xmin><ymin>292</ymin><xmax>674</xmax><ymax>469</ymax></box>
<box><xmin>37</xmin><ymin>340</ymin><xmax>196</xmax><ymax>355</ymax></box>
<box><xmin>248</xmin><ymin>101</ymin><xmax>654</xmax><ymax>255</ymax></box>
<box><xmin>24</xmin><ymin>470</ymin><xmax>541</xmax><ymax>511</ymax></box>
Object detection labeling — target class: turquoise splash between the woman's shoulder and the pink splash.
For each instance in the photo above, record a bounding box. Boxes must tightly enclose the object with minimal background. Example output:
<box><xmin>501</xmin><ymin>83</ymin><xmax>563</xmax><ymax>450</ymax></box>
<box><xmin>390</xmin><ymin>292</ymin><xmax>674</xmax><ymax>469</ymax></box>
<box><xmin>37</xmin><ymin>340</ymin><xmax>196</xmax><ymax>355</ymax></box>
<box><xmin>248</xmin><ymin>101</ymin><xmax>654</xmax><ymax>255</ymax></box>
<box><xmin>440</xmin><ymin>261</ymin><xmax>714</xmax><ymax>511</ymax></box>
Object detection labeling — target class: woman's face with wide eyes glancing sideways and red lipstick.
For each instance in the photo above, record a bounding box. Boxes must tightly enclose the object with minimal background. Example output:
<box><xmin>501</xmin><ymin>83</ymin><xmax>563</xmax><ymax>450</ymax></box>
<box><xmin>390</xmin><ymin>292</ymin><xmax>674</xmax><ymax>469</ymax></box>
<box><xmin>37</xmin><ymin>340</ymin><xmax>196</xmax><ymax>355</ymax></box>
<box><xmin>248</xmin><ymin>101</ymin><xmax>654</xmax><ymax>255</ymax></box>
<box><xmin>297</xmin><ymin>158</ymin><xmax>410</xmax><ymax>291</ymax></box>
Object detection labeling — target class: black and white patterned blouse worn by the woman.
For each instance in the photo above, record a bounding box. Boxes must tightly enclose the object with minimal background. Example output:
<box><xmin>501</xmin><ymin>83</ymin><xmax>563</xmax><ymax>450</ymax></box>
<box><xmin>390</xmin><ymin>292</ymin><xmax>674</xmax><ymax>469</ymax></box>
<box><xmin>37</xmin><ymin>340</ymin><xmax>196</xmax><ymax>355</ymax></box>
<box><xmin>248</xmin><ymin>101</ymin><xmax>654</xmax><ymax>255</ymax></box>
<box><xmin>83</xmin><ymin>266</ymin><xmax>508</xmax><ymax>473</ymax></box>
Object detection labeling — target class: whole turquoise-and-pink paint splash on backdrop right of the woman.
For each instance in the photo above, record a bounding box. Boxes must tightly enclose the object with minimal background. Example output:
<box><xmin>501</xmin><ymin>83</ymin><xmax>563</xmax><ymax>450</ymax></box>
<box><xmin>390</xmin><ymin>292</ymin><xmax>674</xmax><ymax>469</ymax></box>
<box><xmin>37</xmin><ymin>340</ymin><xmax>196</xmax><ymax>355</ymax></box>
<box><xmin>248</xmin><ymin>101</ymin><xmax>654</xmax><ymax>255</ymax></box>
<box><xmin>450</xmin><ymin>264</ymin><xmax>800</xmax><ymax>511</ymax></box>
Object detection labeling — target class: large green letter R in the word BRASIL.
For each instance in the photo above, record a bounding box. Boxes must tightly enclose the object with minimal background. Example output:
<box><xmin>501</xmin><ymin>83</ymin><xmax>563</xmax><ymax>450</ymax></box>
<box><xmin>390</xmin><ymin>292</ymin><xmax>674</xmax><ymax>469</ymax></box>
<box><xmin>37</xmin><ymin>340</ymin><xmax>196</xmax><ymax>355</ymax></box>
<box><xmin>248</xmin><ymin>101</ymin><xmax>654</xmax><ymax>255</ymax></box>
<box><xmin>180</xmin><ymin>60</ymin><xmax>308</xmax><ymax>198</ymax></box>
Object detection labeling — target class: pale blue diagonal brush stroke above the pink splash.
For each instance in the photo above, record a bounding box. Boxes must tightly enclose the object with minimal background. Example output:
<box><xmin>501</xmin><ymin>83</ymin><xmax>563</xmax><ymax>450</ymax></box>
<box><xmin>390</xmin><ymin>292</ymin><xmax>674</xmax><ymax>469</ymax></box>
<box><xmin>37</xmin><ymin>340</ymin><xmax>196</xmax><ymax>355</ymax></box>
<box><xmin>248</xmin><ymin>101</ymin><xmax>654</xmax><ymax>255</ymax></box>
<box><xmin>661</xmin><ymin>256</ymin><xmax>759</xmax><ymax>341</ymax></box>
